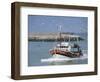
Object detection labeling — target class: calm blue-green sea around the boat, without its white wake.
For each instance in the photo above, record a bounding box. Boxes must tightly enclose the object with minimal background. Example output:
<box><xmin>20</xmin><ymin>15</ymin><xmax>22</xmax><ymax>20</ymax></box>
<box><xmin>28</xmin><ymin>34</ymin><xmax>88</xmax><ymax>66</ymax></box>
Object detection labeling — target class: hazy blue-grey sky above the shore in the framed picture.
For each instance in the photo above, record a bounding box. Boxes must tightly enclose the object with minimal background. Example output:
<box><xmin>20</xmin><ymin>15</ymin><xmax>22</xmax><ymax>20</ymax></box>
<box><xmin>28</xmin><ymin>15</ymin><xmax>88</xmax><ymax>33</ymax></box>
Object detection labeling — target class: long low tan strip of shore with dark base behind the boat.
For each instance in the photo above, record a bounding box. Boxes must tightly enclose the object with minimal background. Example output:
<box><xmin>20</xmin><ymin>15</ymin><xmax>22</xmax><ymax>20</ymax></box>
<box><xmin>28</xmin><ymin>33</ymin><xmax>84</xmax><ymax>41</ymax></box>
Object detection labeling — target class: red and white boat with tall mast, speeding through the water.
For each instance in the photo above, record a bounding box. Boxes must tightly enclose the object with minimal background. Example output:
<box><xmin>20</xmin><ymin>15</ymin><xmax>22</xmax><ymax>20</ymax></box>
<box><xmin>49</xmin><ymin>26</ymin><xmax>83</xmax><ymax>58</ymax></box>
